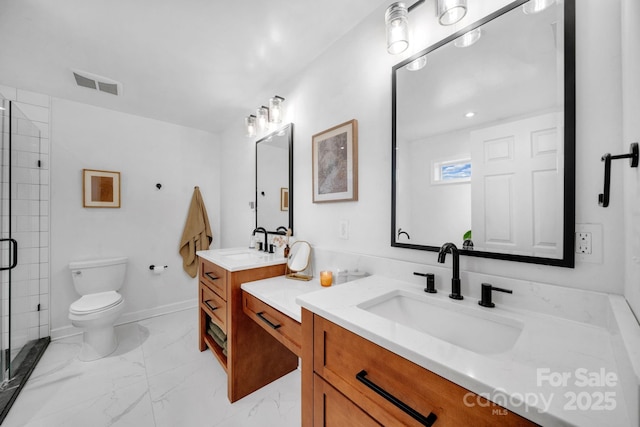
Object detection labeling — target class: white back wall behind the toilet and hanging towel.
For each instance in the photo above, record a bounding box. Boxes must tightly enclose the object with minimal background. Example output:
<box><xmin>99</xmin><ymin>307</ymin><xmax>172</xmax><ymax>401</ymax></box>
<box><xmin>51</xmin><ymin>98</ymin><xmax>221</xmax><ymax>338</ymax></box>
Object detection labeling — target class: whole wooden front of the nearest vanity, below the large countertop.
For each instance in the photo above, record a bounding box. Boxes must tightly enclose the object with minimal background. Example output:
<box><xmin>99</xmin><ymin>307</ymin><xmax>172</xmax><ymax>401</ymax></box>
<box><xmin>302</xmin><ymin>309</ymin><xmax>536</xmax><ymax>427</ymax></box>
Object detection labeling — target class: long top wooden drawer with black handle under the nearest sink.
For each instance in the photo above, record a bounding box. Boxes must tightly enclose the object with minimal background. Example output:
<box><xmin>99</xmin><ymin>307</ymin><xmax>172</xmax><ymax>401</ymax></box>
<box><xmin>313</xmin><ymin>316</ymin><xmax>535</xmax><ymax>427</ymax></box>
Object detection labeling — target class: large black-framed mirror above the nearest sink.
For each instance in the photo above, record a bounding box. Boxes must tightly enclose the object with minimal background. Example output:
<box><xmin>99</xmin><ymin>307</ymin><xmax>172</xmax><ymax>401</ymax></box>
<box><xmin>391</xmin><ymin>0</ymin><xmax>575</xmax><ymax>267</ymax></box>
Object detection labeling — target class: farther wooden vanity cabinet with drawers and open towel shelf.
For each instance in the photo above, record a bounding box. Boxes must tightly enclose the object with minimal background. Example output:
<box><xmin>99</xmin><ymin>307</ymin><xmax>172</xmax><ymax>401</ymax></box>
<box><xmin>198</xmin><ymin>257</ymin><xmax>298</xmax><ymax>402</ymax></box>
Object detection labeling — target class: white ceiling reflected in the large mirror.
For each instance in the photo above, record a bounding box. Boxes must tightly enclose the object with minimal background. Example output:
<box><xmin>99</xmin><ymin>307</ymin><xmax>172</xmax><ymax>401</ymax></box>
<box><xmin>396</xmin><ymin>3</ymin><xmax>564</xmax><ymax>141</ymax></box>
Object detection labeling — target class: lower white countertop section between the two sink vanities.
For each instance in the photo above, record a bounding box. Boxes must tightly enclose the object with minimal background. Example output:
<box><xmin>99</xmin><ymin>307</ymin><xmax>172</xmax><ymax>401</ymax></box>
<box><xmin>241</xmin><ymin>276</ymin><xmax>324</xmax><ymax>323</ymax></box>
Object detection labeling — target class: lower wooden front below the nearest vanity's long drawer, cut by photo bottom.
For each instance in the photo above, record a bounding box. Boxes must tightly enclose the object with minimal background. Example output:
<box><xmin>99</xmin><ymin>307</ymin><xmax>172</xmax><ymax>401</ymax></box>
<box><xmin>313</xmin><ymin>374</ymin><xmax>380</xmax><ymax>427</ymax></box>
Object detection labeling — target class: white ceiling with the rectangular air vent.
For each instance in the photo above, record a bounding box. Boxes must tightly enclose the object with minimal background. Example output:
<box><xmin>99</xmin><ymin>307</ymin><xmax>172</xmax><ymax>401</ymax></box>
<box><xmin>0</xmin><ymin>0</ymin><xmax>390</xmax><ymax>132</ymax></box>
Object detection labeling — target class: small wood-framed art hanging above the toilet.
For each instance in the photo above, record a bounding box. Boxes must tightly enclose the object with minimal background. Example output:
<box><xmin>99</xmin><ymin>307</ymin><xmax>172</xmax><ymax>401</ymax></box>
<box><xmin>82</xmin><ymin>169</ymin><xmax>120</xmax><ymax>208</ymax></box>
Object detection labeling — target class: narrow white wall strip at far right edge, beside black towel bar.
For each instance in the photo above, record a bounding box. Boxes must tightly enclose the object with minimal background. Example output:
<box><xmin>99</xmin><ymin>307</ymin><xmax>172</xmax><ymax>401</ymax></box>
<box><xmin>616</xmin><ymin>0</ymin><xmax>640</xmax><ymax>319</ymax></box>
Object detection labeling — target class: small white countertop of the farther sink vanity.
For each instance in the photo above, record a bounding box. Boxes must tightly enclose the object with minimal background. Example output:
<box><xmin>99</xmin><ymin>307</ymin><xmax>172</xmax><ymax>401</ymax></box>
<box><xmin>196</xmin><ymin>248</ymin><xmax>287</xmax><ymax>271</ymax></box>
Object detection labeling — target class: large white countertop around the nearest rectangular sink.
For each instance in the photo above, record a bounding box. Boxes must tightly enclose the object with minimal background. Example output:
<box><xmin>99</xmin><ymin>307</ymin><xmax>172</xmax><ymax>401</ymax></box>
<box><xmin>296</xmin><ymin>276</ymin><xmax>638</xmax><ymax>427</ymax></box>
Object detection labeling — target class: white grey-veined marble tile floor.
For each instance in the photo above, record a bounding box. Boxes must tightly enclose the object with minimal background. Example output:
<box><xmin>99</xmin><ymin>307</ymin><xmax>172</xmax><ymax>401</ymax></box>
<box><xmin>2</xmin><ymin>308</ymin><xmax>300</xmax><ymax>427</ymax></box>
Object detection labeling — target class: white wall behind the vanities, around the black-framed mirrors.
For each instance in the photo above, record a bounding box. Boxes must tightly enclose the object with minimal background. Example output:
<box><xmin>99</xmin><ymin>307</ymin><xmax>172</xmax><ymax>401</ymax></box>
<box><xmin>222</xmin><ymin>0</ymin><xmax>625</xmax><ymax>294</ymax></box>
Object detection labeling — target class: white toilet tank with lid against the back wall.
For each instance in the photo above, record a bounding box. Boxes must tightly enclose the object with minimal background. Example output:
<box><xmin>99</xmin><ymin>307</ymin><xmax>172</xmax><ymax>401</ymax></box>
<box><xmin>69</xmin><ymin>257</ymin><xmax>127</xmax><ymax>295</ymax></box>
